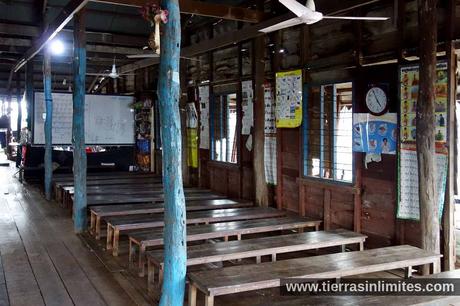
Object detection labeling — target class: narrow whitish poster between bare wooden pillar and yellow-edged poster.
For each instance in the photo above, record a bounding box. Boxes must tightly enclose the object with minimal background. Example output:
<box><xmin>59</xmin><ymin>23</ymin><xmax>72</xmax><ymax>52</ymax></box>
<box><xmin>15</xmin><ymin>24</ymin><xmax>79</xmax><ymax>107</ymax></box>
<box><xmin>264</xmin><ymin>84</ymin><xmax>276</xmax><ymax>185</ymax></box>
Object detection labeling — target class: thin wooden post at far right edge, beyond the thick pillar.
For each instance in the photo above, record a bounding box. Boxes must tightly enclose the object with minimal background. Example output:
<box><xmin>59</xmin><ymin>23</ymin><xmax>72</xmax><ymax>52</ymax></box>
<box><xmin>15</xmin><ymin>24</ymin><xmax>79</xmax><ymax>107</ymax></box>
<box><xmin>442</xmin><ymin>0</ymin><xmax>457</xmax><ymax>271</ymax></box>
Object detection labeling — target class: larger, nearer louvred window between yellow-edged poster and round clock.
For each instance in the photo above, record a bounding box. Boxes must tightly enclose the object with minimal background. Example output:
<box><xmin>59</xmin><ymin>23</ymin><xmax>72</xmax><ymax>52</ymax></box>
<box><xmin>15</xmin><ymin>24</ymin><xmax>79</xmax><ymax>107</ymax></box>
<box><xmin>304</xmin><ymin>83</ymin><xmax>353</xmax><ymax>183</ymax></box>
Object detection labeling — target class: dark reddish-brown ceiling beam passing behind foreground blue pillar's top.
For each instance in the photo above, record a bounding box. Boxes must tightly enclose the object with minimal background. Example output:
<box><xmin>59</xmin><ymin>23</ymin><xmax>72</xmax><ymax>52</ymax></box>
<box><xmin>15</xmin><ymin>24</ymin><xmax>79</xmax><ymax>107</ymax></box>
<box><xmin>92</xmin><ymin>0</ymin><xmax>263</xmax><ymax>23</ymax></box>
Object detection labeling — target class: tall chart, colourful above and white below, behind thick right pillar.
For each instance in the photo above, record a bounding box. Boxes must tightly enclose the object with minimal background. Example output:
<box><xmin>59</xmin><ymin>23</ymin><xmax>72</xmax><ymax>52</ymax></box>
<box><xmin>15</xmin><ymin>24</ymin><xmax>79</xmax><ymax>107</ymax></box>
<box><xmin>397</xmin><ymin>63</ymin><xmax>448</xmax><ymax>220</ymax></box>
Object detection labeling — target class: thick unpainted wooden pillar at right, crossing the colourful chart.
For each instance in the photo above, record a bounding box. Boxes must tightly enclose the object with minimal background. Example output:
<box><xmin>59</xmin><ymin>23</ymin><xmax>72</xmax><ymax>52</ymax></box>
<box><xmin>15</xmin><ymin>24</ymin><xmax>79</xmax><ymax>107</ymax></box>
<box><xmin>416</xmin><ymin>0</ymin><xmax>440</xmax><ymax>274</ymax></box>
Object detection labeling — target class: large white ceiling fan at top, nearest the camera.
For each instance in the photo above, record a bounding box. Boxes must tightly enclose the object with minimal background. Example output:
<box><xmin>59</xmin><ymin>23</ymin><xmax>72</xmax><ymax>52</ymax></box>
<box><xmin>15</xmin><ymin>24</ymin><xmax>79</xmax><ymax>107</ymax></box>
<box><xmin>259</xmin><ymin>0</ymin><xmax>389</xmax><ymax>33</ymax></box>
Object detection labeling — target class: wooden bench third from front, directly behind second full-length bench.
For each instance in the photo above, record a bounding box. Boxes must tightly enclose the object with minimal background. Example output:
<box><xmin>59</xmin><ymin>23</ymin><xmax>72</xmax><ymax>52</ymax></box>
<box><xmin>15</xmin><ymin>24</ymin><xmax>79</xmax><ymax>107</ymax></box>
<box><xmin>129</xmin><ymin>217</ymin><xmax>321</xmax><ymax>277</ymax></box>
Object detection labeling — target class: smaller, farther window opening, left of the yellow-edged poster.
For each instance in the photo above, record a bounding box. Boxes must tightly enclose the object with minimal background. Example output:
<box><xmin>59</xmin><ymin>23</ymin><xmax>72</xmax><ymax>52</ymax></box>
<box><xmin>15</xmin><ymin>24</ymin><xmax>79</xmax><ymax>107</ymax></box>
<box><xmin>212</xmin><ymin>93</ymin><xmax>238</xmax><ymax>164</ymax></box>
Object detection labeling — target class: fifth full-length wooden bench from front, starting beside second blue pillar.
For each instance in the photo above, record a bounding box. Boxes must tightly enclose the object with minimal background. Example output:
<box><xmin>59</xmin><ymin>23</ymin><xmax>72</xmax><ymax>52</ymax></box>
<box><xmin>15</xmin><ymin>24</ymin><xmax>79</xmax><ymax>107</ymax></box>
<box><xmin>90</xmin><ymin>199</ymin><xmax>253</xmax><ymax>239</ymax></box>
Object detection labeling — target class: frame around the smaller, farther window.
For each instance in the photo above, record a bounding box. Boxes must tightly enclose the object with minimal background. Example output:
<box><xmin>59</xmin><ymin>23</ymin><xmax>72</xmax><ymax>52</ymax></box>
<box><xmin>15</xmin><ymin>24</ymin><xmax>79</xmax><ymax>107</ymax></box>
<box><xmin>209</xmin><ymin>86</ymin><xmax>242</xmax><ymax>167</ymax></box>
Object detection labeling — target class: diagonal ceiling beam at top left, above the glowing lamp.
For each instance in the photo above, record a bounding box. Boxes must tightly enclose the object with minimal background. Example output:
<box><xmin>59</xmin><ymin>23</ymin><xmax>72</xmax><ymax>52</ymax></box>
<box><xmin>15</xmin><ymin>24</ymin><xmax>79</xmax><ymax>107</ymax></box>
<box><xmin>13</xmin><ymin>0</ymin><xmax>89</xmax><ymax>72</ymax></box>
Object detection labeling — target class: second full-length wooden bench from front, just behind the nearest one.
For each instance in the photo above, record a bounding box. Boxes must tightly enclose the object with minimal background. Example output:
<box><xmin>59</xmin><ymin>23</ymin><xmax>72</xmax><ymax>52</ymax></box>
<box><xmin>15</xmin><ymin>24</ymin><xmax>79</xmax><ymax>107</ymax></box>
<box><xmin>146</xmin><ymin>229</ymin><xmax>367</xmax><ymax>291</ymax></box>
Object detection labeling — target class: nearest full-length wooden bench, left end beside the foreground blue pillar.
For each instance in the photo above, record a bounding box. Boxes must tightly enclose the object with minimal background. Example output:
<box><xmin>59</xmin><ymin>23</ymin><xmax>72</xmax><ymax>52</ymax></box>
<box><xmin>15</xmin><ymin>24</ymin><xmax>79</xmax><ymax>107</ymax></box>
<box><xmin>188</xmin><ymin>245</ymin><xmax>442</xmax><ymax>306</ymax></box>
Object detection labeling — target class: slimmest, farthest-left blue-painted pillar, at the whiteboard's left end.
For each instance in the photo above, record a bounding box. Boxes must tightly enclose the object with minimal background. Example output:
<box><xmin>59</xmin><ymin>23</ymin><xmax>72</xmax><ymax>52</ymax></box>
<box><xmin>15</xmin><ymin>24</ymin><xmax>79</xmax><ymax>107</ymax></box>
<box><xmin>43</xmin><ymin>48</ymin><xmax>53</xmax><ymax>201</ymax></box>
